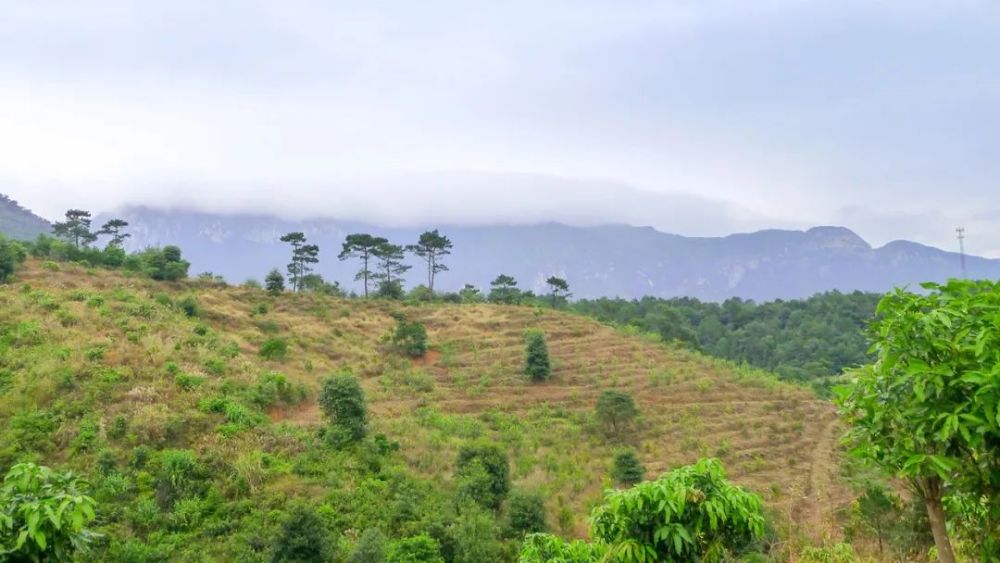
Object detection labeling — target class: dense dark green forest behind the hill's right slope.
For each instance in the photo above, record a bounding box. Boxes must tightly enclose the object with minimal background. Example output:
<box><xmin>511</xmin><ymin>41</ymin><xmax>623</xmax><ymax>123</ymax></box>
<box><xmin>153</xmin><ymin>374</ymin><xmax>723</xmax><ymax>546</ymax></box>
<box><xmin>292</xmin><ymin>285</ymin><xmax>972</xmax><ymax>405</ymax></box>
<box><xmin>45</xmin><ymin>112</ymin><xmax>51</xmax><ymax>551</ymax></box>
<box><xmin>572</xmin><ymin>291</ymin><xmax>879</xmax><ymax>380</ymax></box>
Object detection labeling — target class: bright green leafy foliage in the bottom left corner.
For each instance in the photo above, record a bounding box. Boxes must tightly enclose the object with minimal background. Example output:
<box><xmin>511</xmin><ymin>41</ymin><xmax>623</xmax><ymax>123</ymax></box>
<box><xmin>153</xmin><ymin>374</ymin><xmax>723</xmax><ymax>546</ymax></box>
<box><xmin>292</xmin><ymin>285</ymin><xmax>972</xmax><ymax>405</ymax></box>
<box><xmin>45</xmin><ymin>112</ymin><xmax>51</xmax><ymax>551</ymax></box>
<box><xmin>0</xmin><ymin>463</ymin><xmax>96</xmax><ymax>562</ymax></box>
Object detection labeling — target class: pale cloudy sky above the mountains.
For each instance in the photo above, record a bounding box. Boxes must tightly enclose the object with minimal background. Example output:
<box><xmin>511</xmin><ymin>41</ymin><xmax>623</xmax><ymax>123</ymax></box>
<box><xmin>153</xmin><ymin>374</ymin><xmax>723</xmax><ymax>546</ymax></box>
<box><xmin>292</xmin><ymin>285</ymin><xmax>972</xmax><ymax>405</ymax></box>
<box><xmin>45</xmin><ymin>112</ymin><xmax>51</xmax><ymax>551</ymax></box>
<box><xmin>0</xmin><ymin>0</ymin><xmax>1000</xmax><ymax>257</ymax></box>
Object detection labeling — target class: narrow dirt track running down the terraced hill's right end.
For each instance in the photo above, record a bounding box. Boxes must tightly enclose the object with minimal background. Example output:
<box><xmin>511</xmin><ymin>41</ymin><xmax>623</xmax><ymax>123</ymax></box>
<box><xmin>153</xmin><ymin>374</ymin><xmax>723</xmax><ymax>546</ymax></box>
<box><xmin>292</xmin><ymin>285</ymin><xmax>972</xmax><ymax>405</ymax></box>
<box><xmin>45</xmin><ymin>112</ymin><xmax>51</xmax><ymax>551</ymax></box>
<box><xmin>797</xmin><ymin>418</ymin><xmax>840</xmax><ymax>541</ymax></box>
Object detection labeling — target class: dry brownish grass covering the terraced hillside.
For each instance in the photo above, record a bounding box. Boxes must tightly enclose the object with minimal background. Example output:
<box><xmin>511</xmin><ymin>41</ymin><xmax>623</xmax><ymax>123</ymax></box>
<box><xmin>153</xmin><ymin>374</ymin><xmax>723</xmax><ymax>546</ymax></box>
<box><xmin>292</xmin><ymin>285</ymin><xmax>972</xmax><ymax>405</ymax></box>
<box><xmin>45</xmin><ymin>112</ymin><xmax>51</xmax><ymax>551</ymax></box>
<box><xmin>0</xmin><ymin>262</ymin><xmax>849</xmax><ymax>539</ymax></box>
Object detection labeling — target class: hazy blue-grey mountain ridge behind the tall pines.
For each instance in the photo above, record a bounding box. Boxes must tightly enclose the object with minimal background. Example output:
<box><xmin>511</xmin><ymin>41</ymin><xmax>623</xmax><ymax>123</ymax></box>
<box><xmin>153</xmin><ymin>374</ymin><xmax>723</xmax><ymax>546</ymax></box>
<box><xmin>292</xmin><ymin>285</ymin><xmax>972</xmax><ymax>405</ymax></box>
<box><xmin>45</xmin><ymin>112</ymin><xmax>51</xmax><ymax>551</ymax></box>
<box><xmin>95</xmin><ymin>208</ymin><xmax>1000</xmax><ymax>301</ymax></box>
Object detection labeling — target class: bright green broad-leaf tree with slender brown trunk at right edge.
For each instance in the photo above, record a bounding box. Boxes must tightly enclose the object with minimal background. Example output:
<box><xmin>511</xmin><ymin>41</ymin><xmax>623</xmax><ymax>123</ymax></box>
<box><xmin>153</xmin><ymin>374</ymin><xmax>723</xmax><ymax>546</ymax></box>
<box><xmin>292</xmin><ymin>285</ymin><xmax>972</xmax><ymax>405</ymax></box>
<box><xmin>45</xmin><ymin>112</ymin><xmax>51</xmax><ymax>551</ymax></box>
<box><xmin>837</xmin><ymin>280</ymin><xmax>1000</xmax><ymax>562</ymax></box>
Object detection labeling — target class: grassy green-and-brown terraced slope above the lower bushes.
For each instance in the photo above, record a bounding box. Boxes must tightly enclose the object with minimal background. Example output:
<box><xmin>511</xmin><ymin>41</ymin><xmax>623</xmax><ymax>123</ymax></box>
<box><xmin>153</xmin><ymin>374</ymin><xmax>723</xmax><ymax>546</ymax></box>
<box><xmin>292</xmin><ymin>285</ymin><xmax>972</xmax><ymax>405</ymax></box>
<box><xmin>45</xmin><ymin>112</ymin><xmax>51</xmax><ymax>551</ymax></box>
<box><xmin>0</xmin><ymin>262</ymin><xmax>848</xmax><ymax>556</ymax></box>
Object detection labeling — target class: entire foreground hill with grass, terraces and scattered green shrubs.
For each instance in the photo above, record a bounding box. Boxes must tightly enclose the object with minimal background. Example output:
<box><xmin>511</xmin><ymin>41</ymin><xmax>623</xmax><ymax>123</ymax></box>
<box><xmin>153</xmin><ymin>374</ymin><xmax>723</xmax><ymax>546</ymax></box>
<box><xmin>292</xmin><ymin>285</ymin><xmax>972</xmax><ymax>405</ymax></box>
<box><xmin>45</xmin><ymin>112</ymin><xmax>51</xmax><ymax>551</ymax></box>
<box><xmin>0</xmin><ymin>252</ymin><xmax>992</xmax><ymax>562</ymax></box>
